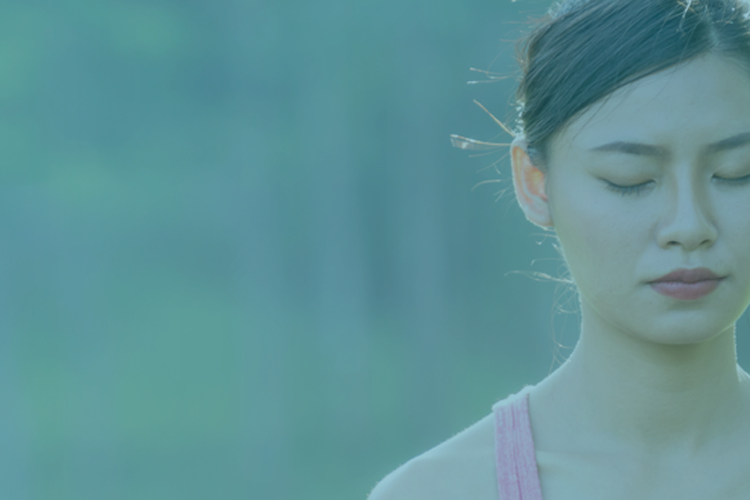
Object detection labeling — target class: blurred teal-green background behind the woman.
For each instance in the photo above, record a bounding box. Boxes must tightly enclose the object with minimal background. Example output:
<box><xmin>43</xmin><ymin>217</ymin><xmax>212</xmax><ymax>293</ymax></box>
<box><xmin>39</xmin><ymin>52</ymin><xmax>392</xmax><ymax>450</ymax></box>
<box><xmin>0</xmin><ymin>0</ymin><xmax>747</xmax><ymax>500</ymax></box>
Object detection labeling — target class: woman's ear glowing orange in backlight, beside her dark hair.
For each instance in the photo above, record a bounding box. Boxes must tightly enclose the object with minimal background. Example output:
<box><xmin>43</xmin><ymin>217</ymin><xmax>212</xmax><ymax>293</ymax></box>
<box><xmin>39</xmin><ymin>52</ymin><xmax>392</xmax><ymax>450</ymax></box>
<box><xmin>510</xmin><ymin>138</ymin><xmax>553</xmax><ymax>227</ymax></box>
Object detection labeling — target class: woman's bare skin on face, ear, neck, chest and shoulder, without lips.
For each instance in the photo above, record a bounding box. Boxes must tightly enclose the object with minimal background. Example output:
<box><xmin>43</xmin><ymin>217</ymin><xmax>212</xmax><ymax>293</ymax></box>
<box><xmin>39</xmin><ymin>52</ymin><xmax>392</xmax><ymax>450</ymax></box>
<box><xmin>371</xmin><ymin>56</ymin><xmax>750</xmax><ymax>500</ymax></box>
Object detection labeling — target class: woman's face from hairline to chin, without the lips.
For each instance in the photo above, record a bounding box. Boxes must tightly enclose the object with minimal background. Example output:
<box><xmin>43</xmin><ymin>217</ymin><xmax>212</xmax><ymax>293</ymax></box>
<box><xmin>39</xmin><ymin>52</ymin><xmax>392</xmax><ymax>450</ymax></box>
<box><xmin>545</xmin><ymin>56</ymin><xmax>750</xmax><ymax>344</ymax></box>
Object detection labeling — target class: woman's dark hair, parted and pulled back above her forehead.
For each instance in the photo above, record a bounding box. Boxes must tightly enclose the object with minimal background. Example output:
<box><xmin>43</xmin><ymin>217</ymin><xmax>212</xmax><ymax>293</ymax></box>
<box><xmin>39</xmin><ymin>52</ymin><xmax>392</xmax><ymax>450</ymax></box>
<box><xmin>516</xmin><ymin>0</ymin><xmax>750</xmax><ymax>171</ymax></box>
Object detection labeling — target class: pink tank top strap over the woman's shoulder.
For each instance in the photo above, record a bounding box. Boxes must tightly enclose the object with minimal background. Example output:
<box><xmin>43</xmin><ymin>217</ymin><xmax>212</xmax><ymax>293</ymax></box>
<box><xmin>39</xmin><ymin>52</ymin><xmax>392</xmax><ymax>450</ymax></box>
<box><xmin>492</xmin><ymin>385</ymin><xmax>542</xmax><ymax>500</ymax></box>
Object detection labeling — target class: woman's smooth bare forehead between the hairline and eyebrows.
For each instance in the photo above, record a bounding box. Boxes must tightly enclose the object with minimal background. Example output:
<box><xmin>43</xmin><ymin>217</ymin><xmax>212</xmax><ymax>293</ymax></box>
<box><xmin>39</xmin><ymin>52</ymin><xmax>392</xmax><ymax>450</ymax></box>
<box><xmin>549</xmin><ymin>56</ymin><xmax>750</xmax><ymax>162</ymax></box>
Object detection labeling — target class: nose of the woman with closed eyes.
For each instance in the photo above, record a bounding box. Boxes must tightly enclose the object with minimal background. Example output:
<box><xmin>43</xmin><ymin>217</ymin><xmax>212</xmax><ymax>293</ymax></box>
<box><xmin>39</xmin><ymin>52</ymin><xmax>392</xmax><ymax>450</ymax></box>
<box><xmin>657</xmin><ymin>180</ymin><xmax>718</xmax><ymax>252</ymax></box>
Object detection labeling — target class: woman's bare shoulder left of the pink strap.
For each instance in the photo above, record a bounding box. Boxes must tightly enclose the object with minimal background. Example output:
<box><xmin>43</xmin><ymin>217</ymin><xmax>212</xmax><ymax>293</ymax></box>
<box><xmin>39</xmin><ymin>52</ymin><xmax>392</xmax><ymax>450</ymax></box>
<box><xmin>369</xmin><ymin>414</ymin><xmax>498</xmax><ymax>500</ymax></box>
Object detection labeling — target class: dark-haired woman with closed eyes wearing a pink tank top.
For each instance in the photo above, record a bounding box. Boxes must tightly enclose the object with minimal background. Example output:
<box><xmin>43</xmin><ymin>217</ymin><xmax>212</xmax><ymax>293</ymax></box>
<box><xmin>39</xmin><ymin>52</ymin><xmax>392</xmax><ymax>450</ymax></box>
<box><xmin>370</xmin><ymin>0</ymin><xmax>750</xmax><ymax>500</ymax></box>
